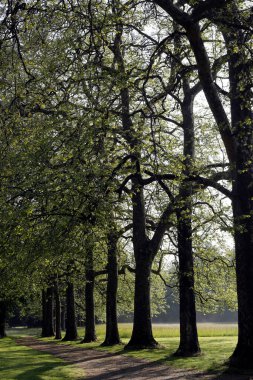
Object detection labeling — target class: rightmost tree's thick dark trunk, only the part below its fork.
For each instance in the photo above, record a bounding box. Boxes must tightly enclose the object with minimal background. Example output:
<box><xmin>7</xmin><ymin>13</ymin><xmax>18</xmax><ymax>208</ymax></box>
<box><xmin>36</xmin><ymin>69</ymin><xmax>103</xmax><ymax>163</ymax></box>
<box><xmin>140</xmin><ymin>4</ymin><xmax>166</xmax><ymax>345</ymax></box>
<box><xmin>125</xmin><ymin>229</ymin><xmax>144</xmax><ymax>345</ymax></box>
<box><xmin>230</xmin><ymin>171</ymin><xmax>253</xmax><ymax>369</ymax></box>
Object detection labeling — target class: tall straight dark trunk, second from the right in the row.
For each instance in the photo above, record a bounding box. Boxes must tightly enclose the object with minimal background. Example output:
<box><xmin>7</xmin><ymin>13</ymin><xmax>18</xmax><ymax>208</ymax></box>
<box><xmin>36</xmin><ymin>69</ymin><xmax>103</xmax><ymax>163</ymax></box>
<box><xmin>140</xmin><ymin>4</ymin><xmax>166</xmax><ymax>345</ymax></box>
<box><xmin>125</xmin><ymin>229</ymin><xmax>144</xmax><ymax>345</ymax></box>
<box><xmin>175</xmin><ymin>79</ymin><xmax>200</xmax><ymax>356</ymax></box>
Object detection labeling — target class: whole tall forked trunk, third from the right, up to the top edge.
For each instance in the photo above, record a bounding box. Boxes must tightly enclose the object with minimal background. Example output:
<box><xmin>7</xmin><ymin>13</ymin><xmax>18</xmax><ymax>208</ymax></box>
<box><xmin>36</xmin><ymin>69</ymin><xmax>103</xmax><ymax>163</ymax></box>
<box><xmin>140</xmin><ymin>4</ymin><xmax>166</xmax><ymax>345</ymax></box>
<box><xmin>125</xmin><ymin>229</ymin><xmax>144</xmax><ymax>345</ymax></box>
<box><xmin>112</xmin><ymin>6</ymin><xmax>169</xmax><ymax>349</ymax></box>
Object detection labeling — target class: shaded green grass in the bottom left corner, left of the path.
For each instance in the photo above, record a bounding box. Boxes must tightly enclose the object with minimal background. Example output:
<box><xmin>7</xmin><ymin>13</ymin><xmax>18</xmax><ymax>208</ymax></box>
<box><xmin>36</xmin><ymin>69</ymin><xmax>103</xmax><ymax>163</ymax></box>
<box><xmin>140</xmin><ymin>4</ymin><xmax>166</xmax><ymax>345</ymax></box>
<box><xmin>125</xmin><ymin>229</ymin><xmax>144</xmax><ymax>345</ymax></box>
<box><xmin>0</xmin><ymin>338</ymin><xmax>84</xmax><ymax>380</ymax></box>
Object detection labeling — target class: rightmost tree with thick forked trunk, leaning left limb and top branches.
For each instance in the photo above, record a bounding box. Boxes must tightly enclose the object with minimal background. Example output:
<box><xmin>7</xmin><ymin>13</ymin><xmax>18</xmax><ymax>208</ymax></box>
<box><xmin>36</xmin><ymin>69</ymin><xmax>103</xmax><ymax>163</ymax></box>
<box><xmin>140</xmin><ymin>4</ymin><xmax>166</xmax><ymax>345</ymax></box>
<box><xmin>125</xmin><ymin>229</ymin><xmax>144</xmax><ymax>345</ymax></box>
<box><xmin>152</xmin><ymin>0</ymin><xmax>253</xmax><ymax>368</ymax></box>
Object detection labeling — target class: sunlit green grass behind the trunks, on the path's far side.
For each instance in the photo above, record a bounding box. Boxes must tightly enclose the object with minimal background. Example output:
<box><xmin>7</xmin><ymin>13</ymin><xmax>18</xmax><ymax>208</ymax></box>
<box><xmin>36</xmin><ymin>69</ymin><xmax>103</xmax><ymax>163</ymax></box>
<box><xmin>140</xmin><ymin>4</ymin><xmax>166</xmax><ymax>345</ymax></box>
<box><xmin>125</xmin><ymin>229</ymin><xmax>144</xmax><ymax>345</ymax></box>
<box><xmin>6</xmin><ymin>323</ymin><xmax>237</xmax><ymax>371</ymax></box>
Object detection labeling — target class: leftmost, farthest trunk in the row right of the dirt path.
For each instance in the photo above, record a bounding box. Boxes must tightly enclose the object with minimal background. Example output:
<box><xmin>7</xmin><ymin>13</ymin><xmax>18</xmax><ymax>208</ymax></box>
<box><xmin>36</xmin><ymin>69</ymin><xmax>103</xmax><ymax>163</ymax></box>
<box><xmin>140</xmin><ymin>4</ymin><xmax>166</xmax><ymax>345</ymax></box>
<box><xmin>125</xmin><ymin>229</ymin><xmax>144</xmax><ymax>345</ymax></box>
<box><xmin>41</xmin><ymin>286</ymin><xmax>54</xmax><ymax>338</ymax></box>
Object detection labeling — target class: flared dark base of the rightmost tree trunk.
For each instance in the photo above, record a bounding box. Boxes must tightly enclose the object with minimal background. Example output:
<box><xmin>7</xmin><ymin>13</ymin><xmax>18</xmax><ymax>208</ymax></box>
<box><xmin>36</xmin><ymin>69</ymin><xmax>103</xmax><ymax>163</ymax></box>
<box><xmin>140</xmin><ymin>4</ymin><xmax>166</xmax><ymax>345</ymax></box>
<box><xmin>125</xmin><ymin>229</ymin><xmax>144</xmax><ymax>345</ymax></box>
<box><xmin>228</xmin><ymin>344</ymin><xmax>253</xmax><ymax>370</ymax></box>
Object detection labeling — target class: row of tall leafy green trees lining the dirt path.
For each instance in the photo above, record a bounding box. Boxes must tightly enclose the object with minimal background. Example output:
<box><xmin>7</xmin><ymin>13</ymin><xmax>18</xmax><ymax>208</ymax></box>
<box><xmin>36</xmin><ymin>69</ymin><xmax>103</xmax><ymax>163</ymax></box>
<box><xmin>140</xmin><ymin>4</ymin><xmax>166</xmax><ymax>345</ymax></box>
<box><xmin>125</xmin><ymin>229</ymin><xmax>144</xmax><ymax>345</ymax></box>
<box><xmin>0</xmin><ymin>0</ymin><xmax>253</xmax><ymax>367</ymax></box>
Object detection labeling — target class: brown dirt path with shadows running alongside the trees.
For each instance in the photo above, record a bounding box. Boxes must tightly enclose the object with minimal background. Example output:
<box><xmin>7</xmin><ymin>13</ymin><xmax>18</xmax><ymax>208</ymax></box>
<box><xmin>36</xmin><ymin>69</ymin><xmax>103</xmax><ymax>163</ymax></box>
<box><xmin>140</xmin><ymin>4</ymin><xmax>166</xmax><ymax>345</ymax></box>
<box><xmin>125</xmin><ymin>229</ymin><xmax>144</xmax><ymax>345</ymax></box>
<box><xmin>16</xmin><ymin>337</ymin><xmax>253</xmax><ymax>380</ymax></box>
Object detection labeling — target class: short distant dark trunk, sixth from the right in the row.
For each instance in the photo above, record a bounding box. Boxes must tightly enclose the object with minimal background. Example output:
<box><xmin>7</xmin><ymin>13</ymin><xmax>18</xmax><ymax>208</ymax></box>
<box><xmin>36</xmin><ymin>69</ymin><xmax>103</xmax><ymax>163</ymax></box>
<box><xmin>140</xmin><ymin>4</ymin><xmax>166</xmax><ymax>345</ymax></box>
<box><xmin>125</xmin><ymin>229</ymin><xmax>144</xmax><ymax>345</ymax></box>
<box><xmin>63</xmin><ymin>282</ymin><xmax>78</xmax><ymax>340</ymax></box>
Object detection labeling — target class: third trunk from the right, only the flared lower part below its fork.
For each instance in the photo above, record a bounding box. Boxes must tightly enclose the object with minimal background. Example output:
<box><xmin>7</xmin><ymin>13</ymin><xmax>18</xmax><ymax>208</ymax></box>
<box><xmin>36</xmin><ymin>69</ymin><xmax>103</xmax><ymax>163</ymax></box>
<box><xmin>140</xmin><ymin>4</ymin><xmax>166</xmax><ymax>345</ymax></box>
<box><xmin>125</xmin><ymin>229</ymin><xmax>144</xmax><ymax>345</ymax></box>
<box><xmin>125</xmin><ymin>254</ymin><xmax>158</xmax><ymax>349</ymax></box>
